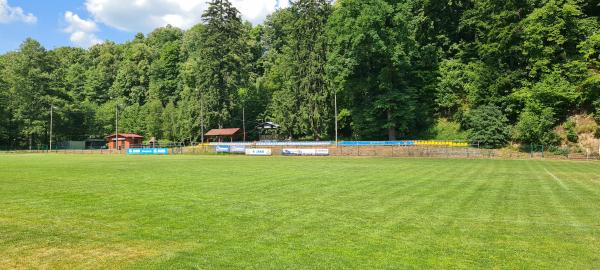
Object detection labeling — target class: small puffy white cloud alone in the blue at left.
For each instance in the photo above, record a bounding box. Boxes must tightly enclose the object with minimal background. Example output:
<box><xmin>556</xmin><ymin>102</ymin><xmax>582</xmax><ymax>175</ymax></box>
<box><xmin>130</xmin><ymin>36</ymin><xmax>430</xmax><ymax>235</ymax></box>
<box><xmin>63</xmin><ymin>11</ymin><xmax>102</xmax><ymax>47</ymax></box>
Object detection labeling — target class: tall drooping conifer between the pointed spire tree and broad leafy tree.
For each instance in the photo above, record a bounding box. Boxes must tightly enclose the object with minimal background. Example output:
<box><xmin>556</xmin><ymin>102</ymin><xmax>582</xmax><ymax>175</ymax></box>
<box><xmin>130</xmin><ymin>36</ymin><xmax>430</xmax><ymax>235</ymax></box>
<box><xmin>265</xmin><ymin>0</ymin><xmax>333</xmax><ymax>139</ymax></box>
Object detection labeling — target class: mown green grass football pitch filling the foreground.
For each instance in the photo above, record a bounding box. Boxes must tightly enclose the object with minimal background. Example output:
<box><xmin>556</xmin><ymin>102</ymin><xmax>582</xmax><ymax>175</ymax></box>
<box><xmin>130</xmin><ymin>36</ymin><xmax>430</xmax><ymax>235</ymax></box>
<box><xmin>0</xmin><ymin>155</ymin><xmax>600</xmax><ymax>269</ymax></box>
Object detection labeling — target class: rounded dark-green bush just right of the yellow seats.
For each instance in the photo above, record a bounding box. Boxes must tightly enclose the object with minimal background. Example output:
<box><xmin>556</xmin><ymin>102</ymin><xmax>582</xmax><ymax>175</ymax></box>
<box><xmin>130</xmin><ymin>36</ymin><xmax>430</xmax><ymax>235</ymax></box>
<box><xmin>463</xmin><ymin>105</ymin><xmax>510</xmax><ymax>148</ymax></box>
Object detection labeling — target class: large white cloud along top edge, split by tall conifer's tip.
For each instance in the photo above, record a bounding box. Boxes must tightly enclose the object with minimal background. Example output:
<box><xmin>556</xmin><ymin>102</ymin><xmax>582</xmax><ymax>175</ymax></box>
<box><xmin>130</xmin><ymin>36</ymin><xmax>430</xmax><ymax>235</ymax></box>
<box><xmin>85</xmin><ymin>0</ymin><xmax>288</xmax><ymax>33</ymax></box>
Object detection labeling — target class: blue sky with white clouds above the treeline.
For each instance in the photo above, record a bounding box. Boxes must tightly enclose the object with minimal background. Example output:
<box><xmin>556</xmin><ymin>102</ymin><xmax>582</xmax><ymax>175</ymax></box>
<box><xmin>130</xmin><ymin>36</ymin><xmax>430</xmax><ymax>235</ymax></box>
<box><xmin>0</xmin><ymin>0</ymin><xmax>288</xmax><ymax>53</ymax></box>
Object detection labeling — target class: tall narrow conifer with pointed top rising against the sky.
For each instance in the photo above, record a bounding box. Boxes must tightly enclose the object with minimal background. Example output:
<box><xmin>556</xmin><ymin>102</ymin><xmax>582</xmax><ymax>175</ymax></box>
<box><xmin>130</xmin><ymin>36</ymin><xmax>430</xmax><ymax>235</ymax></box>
<box><xmin>196</xmin><ymin>0</ymin><xmax>250</xmax><ymax>127</ymax></box>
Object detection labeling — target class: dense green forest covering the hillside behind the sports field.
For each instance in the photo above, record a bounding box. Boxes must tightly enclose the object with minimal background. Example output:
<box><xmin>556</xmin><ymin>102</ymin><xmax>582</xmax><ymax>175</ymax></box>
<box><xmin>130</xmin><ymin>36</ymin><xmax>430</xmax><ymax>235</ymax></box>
<box><xmin>0</xmin><ymin>0</ymin><xmax>600</xmax><ymax>148</ymax></box>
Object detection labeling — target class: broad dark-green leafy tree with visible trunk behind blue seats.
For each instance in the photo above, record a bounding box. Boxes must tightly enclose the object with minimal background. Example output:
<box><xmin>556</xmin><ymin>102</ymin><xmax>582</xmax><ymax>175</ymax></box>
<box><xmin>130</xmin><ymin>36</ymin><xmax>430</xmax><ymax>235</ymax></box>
<box><xmin>328</xmin><ymin>0</ymin><xmax>419</xmax><ymax>140</ymax></box>
